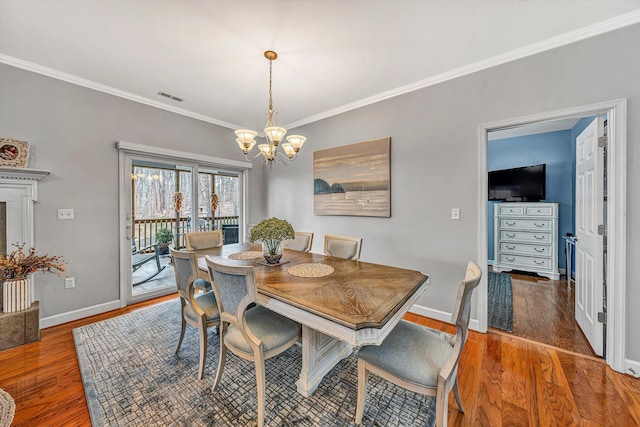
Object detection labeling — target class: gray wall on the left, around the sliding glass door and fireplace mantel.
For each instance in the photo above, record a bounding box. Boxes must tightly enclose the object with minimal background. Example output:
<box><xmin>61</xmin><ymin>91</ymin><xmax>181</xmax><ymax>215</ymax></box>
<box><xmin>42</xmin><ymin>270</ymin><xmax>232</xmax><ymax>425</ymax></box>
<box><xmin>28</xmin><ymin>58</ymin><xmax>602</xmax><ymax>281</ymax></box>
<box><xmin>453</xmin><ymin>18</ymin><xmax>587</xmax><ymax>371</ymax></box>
<box><xmin>0</xmin><ymin>64</ymin><xmax>266</xmax><ymax>317</ymax></box>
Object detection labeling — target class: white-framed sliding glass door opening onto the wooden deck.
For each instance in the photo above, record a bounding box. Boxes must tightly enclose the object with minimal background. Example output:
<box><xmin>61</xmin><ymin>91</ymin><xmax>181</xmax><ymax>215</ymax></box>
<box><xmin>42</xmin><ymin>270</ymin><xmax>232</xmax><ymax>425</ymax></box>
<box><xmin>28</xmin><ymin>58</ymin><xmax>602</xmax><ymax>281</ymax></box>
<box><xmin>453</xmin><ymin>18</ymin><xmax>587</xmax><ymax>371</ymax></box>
<box><xmin>118</xmin><ymin>142</ymin><xmax>251</xmax><ymax>307</ymax></box>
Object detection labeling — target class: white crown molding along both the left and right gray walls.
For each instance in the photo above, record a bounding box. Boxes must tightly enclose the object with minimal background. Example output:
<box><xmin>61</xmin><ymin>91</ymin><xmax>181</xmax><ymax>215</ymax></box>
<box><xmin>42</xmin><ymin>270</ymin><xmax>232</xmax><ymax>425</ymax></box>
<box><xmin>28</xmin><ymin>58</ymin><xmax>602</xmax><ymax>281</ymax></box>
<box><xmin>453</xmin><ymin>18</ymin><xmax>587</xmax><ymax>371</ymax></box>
<box><xmin>5</xmin><ymin>10</ymin><xmax>640</xmax><ymax>129</ymax></box>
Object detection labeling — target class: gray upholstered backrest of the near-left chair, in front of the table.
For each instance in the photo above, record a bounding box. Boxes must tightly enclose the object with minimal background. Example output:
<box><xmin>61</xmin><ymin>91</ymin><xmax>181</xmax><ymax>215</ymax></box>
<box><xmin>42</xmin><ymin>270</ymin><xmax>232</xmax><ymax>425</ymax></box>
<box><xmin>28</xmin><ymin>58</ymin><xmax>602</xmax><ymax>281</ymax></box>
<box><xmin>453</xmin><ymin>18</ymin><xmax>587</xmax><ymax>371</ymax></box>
<box><xmin>205</xmin><ymin>256</ymin><xmax>258</xmax><ymax>330</ymax></box>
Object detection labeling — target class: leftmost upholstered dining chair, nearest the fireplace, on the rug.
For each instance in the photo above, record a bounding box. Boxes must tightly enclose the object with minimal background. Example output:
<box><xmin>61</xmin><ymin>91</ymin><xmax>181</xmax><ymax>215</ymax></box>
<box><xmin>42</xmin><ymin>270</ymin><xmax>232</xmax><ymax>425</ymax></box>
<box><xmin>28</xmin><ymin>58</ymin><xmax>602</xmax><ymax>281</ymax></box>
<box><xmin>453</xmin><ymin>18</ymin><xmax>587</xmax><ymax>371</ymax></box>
<box><xmin>169</xmin><ymin>248</ymin><xmax>220</xmax><ymax>380</ymax></box>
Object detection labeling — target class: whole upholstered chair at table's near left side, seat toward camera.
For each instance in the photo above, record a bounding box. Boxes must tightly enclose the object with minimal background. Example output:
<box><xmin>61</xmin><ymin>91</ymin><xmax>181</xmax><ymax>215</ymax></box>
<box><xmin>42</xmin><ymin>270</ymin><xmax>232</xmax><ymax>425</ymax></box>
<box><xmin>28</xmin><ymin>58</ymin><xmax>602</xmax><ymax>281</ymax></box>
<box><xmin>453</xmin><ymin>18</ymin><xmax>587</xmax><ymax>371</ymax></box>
<box><xmin>206</xmin><ymin>257</ymin><xmax>301</xmax><ymax>427</ymax></box>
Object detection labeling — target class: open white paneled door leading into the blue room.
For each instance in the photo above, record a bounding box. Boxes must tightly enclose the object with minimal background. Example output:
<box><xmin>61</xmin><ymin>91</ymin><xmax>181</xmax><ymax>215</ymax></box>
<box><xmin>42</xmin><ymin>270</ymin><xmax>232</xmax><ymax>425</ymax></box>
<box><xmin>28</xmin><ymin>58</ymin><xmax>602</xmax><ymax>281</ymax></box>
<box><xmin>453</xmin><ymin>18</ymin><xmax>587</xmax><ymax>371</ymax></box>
<box><xmin>575</xmin><ymin>117</ymin><xmax>604</xmax><ymax>356</ymax></box>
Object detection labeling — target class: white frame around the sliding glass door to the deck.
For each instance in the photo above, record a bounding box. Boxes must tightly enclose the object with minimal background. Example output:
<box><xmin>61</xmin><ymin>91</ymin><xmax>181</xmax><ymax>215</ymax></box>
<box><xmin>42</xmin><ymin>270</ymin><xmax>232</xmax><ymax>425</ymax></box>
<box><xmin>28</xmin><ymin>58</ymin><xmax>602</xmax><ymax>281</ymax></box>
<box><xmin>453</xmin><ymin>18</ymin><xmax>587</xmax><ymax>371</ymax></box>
<box><xmin>116</xmin><ymin>141</ymin><xmax>253</xmax><ymax>308</ymax></box>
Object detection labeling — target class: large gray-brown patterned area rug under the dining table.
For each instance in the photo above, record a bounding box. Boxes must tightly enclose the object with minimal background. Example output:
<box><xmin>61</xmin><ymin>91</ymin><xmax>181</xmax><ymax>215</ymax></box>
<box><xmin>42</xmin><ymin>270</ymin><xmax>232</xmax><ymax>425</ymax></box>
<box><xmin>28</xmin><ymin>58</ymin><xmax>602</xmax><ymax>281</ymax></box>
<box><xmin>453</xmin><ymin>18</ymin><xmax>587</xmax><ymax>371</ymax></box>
<box><xmin>73</xmin><ymin>300</ymin><xmax>435</xmax><ymax>427</ymax></box>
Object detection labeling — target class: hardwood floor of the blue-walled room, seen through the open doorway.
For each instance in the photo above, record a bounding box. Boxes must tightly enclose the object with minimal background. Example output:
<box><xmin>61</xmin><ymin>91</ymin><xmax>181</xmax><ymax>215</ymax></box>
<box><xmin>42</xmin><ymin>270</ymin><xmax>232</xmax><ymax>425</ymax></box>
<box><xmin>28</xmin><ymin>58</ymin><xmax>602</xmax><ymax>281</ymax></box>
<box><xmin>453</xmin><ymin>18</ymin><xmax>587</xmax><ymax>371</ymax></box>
<box><xmin>509</xmin><ymin>273</ymin><xmax>596</xmax><ymax>357</ymax></box>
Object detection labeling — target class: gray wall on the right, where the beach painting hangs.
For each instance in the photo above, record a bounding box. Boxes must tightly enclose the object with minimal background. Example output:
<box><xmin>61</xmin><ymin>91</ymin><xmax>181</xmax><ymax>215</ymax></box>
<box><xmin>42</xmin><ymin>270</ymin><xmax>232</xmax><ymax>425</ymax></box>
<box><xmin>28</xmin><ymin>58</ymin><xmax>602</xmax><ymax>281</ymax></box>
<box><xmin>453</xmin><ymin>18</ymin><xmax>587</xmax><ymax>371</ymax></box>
<box><xmin>269</xmin><ymin>25</ymin><xmax>640</xmax><ymax>360</ymax></box>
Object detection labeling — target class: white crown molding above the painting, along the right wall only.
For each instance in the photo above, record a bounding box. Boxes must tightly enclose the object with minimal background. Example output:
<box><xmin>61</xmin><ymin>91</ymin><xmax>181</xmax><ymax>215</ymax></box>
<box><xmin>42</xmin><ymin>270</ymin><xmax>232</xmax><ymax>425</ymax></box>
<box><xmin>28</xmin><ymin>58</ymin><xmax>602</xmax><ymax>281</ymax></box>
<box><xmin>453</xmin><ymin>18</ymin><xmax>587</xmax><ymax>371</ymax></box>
<box><xmin>284</xmin><ymin>9</ymin><xmax>640</xmax><ymax>129</ymax></box>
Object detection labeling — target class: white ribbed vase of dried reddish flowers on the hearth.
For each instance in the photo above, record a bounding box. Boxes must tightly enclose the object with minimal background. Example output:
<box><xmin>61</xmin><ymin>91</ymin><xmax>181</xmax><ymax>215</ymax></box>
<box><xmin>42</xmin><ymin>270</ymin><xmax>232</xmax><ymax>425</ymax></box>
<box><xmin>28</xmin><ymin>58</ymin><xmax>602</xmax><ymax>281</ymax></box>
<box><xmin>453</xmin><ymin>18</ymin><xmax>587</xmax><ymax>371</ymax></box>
<box><xmin>0</xmin><ymin>243</ymin><xmax>65</xmax><ymax>313</ymax></box>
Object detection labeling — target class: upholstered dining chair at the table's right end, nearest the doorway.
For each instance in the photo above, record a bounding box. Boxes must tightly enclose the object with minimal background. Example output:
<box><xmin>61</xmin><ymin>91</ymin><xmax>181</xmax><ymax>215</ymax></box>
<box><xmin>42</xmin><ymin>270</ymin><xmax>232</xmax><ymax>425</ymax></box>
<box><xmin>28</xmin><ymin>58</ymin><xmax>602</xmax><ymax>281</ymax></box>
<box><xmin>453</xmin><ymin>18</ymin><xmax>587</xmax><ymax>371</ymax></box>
<box><xmin>356</xmin><ymin>261</ymin><xmax>482</xmax><ymax>427</ymax></box>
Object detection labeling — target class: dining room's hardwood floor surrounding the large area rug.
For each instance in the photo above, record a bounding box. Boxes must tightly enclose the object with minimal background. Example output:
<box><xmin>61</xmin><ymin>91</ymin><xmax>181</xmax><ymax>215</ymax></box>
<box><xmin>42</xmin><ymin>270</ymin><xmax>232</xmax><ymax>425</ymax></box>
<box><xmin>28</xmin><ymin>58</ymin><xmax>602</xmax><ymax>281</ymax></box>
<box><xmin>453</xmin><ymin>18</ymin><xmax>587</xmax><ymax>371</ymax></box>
<box><xmin>0</xmin><ymin>295</ymin><xmax>640</xmax><ymax>427</ymax></box>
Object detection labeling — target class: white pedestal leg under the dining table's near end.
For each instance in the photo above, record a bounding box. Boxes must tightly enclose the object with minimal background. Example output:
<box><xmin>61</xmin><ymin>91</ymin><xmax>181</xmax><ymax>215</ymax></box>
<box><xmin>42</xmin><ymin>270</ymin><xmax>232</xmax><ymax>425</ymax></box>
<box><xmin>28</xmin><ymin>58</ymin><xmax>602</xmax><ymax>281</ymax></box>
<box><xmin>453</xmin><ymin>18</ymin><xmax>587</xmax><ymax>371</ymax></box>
<box><xmin>296</xmin><ymin>325</ymin><xmax>353</xmax><ymax>397</ymax></box>
